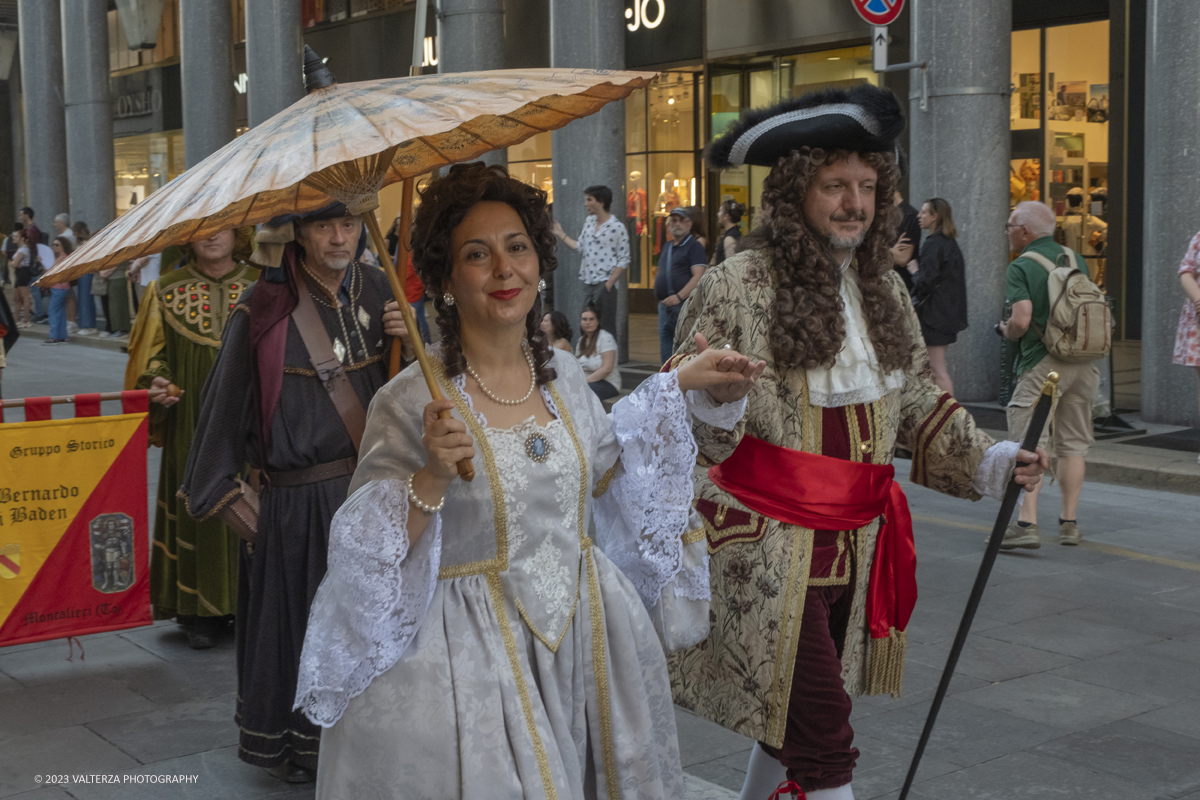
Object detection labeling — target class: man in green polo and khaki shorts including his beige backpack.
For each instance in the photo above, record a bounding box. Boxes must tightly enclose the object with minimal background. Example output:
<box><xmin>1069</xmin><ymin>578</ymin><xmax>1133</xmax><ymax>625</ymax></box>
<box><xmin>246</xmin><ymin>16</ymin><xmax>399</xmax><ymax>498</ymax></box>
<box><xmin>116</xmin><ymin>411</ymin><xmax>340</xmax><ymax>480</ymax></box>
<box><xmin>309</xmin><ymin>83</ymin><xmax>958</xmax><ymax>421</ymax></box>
<box><xmin>997</xmin><ymin>201</ymin><xmax>1112</xmax><ymax>549</ymax></box>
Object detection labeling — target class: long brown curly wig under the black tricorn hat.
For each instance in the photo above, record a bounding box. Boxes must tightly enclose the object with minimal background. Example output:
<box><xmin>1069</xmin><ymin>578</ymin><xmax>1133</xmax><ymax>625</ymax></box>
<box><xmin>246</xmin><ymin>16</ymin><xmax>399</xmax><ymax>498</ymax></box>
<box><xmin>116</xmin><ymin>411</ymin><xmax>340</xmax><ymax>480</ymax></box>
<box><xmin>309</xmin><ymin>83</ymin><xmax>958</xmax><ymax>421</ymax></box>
<box><xmin>742</xmin><ymin>148</ymin><xmax>913</xmax><ymax>372</ymax></box>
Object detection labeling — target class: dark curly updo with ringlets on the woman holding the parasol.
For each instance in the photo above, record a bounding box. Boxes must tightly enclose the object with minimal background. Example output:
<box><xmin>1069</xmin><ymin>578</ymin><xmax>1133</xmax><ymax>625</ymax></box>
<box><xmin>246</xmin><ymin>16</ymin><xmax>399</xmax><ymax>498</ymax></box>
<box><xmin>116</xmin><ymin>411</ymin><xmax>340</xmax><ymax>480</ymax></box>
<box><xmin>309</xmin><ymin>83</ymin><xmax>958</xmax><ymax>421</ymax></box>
<box><xmin>413</xmin><ymin>161</ymin><xmax>558</xmax><ymax>385</ymax></box>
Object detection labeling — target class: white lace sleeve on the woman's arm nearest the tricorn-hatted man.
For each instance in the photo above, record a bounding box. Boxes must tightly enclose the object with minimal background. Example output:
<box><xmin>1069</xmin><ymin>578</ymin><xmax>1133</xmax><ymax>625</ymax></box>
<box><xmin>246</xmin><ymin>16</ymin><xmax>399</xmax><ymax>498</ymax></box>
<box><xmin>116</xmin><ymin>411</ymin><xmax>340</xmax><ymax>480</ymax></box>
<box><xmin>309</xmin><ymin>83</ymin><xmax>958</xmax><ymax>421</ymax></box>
<box><xmin>593</xmin><ymin>372</ymin><xmax>707</xmax><ymax>608</ymax></box>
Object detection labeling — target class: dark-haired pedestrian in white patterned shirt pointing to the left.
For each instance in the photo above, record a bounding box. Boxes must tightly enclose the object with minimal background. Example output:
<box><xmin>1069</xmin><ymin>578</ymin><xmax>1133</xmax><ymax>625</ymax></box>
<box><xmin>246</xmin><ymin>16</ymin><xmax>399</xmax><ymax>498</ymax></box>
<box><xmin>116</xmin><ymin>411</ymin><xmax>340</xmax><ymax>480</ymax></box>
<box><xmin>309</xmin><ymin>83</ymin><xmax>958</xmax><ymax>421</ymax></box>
<box><xmin>554</xmin><ymin>186</ymin><xmax>629</xmax><ymax>331</ymax></box>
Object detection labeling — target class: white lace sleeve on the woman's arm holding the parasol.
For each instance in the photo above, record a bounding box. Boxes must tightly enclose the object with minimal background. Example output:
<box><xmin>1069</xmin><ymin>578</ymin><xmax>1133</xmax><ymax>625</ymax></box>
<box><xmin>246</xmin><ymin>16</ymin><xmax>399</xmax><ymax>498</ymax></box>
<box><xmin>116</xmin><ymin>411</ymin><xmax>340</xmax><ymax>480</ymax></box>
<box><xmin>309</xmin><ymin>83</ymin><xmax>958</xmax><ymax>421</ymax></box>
<box><xmin>294</xmin><ymin>480</ymin><xmax>442</xmax><ymax>728</ymax></box>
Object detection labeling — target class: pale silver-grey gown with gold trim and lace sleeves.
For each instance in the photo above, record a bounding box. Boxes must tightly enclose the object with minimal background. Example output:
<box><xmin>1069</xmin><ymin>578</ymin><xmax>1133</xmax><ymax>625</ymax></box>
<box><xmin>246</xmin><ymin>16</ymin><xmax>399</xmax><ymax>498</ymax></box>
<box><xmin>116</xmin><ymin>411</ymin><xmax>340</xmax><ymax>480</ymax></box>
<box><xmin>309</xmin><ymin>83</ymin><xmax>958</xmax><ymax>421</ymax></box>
<box><xmin>296</xmin><ymin>350</ymin><xmax>744</xmax><ymax>800</ymax></box>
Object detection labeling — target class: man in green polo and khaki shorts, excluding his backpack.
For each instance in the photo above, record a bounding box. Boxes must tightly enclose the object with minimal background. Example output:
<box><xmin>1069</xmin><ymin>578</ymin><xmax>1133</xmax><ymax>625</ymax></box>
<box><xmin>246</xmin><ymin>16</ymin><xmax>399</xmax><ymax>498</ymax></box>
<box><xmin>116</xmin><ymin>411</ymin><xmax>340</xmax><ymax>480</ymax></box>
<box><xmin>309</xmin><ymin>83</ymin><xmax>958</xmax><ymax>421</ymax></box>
<box><xmin>1000</xmin><ymin>201</ymin><xmax>1100</xmax><ymax>549</ymax></box>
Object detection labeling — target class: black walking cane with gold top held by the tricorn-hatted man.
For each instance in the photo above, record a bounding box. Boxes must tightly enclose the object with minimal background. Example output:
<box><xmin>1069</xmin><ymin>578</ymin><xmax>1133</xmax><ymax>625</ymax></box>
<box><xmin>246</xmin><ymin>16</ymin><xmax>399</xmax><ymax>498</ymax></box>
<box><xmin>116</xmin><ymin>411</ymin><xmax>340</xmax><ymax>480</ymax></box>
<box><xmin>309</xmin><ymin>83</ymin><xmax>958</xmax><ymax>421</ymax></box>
<box><xmin>900</xmin><ymin>372</ymin><xmax>1058</xmax><ymax>800</ymax></box>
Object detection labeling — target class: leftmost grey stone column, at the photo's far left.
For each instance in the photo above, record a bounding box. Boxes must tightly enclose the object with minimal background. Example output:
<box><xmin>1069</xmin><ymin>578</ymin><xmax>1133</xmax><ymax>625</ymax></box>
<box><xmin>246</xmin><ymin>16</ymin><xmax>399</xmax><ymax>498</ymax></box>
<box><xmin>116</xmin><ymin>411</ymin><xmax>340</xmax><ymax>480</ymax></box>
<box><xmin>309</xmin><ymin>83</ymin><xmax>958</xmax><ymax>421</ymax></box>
<box><xmin>17</xmin><ymin>0</ymin><xmax>68</xmax><ymax>233</ymax></box>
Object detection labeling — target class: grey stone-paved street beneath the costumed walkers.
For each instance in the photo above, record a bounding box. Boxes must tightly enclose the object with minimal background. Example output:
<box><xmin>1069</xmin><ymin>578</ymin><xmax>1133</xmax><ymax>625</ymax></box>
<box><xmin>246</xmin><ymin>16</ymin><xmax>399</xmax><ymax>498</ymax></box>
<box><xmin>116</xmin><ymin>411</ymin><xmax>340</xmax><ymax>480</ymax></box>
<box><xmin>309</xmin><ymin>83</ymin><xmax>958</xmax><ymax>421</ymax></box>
<box><xmin>0</xmin><ymin>338</ymin><xmax>1200</xmax><ymax>800</ymax></box>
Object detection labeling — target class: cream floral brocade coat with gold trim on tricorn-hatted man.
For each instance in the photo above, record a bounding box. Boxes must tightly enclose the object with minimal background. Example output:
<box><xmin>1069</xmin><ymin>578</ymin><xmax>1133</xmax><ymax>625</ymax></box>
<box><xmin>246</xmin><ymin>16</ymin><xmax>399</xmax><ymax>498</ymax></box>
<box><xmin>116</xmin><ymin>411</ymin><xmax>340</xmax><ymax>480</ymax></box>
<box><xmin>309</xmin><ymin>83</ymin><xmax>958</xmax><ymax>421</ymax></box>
<box><xmin>668</xmin><ymin>251</ymin><xmax>994</xmax><ymax>747</ymax></box>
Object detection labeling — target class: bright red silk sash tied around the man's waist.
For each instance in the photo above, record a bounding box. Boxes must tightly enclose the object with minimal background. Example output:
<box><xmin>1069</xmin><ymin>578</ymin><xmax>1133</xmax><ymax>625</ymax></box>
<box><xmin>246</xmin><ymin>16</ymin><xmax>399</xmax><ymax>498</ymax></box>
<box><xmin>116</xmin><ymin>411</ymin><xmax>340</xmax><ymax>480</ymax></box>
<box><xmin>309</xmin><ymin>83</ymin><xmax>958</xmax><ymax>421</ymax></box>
<box><xmin>708</xmin><ymin>435</ymin><xmax>917</xmax><ymax>639</ymax></box>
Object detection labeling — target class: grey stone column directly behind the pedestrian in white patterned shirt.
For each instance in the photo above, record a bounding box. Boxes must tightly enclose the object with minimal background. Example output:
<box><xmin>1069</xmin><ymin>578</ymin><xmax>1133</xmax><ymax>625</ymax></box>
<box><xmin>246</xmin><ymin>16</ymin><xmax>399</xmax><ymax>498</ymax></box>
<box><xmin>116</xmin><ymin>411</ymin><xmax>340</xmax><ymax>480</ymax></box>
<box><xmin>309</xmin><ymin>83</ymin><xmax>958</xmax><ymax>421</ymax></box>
<box><xmin>550</xmin><ymin>0</ymin><xmax>629</xmax><ymax>362</ymax></box>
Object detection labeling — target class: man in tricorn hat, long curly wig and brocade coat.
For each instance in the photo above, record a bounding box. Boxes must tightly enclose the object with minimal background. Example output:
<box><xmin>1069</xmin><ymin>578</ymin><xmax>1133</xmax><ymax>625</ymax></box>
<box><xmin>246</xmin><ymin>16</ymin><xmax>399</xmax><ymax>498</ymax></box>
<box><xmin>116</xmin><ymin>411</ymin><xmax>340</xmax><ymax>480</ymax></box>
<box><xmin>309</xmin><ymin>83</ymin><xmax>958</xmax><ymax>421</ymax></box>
<box><xmin>668</xmin><ymin>85</ymin><xmax>1045</xmax><ymax>800</ymax></box>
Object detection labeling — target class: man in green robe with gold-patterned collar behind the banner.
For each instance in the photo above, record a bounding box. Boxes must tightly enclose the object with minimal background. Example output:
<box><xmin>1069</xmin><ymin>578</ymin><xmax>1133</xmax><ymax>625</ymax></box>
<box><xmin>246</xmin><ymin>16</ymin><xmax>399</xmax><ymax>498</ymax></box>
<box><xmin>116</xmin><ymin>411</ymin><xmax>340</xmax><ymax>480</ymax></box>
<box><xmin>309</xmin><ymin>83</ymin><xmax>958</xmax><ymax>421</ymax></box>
<box><xmin>130</xmin><ymin>228</ymin><xmax>258</xmax><ymax>650</ymax></box>
